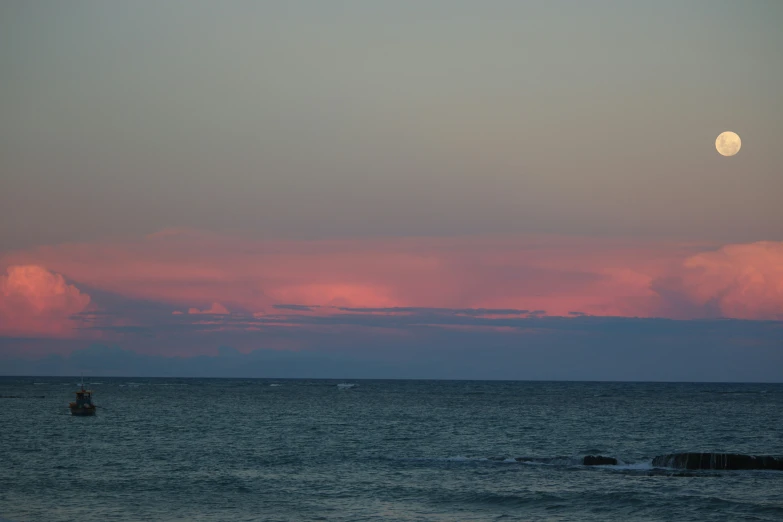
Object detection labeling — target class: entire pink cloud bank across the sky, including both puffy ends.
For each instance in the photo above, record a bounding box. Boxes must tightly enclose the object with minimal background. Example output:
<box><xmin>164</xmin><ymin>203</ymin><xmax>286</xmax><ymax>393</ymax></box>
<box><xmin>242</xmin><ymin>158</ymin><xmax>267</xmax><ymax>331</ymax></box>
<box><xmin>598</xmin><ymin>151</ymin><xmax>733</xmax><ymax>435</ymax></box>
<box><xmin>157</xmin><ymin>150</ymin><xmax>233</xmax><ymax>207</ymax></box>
<box><xmin>0</xmin><ymin>229</ymin><xmax>783</xmax><ymax>348</ymax></box>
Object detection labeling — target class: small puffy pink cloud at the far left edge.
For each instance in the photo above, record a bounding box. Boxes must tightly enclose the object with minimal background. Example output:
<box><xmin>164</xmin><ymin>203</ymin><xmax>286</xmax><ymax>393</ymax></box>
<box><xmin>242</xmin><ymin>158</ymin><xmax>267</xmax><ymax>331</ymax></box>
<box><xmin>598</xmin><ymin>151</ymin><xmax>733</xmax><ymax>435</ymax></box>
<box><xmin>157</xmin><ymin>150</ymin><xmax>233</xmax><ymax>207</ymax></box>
<box><xmin>0</xmin><ymin>265</ymin><xmax>90</xmax><ymax>337</ymax></box>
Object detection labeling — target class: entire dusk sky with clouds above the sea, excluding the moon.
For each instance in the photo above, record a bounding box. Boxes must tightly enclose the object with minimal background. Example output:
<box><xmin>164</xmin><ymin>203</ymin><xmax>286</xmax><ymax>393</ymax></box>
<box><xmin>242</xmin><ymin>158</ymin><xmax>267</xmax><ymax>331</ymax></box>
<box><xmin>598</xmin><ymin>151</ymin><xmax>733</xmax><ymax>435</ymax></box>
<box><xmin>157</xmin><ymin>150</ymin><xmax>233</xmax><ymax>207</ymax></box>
<box><xmin>0</xmin><ymin>0</ymin><xmax>783</xmax><ymax>381</ymax></box>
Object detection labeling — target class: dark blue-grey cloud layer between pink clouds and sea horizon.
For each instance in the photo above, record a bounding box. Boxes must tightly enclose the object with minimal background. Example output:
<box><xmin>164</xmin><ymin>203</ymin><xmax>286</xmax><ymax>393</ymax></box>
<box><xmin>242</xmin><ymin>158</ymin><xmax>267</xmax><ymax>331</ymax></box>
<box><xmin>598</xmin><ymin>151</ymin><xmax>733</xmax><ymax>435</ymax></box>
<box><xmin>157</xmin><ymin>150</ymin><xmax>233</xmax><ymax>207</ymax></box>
<box><xmin>0</xmin><ymin>313</ymin><xmax>783</xmax><ymax>382</ymax></box>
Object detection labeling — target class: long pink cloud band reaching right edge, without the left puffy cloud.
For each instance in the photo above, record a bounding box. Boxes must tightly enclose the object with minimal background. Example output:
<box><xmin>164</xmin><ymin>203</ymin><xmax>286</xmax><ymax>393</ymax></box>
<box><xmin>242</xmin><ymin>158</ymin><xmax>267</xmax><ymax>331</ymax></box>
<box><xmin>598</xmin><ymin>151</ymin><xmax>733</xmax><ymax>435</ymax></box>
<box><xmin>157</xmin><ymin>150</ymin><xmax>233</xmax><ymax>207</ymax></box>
<box><xmin>0</xmin><ymin>230</ymin><xmax>783</xmax><ymax>340</ymax></box>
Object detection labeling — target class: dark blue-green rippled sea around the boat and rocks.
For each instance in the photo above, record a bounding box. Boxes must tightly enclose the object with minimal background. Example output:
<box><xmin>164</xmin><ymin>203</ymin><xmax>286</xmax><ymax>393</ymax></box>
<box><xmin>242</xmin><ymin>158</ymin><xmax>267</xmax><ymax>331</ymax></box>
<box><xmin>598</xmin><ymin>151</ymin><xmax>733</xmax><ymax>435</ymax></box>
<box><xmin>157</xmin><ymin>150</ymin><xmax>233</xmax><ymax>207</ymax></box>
<box><xmin>0</xmin><ymin>377</ymin><xmax>783</xmax><ymax>522</ymax></box>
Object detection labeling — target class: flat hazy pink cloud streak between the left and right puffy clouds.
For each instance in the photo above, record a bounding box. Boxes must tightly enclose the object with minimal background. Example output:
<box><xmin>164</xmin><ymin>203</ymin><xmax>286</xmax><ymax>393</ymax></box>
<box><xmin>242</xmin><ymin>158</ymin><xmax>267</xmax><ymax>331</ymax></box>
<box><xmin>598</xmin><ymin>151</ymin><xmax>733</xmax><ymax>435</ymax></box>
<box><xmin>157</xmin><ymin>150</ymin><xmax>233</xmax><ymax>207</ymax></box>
<box><xmin>4</xmin><ymin>232</ymin><xmax>681</xmax><ymax>314</ymax></box>
